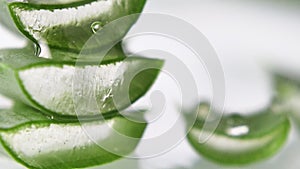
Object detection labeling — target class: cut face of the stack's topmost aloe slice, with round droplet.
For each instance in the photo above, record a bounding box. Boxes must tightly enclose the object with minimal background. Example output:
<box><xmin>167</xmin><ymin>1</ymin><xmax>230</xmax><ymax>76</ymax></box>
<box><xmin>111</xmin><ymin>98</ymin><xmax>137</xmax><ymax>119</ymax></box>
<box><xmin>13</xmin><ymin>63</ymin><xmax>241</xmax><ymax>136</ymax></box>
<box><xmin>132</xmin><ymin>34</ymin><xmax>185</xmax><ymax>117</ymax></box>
<box><xmin>9</xmin><ymin>0</ymin><xmax>145</xmax><ymax>51</ymax></box>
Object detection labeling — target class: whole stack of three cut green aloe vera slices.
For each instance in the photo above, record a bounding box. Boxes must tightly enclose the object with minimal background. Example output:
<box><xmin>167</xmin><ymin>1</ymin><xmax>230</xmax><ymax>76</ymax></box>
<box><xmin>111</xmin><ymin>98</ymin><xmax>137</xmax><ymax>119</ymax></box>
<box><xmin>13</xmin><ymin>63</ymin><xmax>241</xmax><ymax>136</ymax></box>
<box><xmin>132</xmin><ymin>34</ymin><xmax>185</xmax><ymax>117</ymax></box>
<box><xmin>0</xmin><ymin>0</ymin><xmax>163</xmax><ymax>169</ymax></box>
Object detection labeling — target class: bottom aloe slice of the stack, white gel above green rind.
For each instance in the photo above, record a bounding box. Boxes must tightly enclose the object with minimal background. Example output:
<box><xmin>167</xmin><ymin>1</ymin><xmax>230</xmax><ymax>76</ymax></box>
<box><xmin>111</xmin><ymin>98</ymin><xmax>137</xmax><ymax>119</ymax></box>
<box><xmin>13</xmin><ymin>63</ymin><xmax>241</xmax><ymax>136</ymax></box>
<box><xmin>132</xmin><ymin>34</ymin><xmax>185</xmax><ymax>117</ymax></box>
<box><xmin>0</xmin><ymin>103</ymin><xmax>146</xmax><ymax>169</ymax></box>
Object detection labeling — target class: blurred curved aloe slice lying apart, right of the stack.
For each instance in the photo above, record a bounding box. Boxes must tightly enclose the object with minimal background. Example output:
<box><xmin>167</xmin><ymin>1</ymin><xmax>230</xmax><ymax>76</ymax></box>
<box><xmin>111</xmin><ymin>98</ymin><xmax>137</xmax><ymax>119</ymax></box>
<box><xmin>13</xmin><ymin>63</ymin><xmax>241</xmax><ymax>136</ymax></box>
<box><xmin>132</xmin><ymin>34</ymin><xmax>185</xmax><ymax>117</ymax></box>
<box><xmin>188</xmin><ymin>104</ymin><xmax>290</xmax><ymax>165</ymax></box>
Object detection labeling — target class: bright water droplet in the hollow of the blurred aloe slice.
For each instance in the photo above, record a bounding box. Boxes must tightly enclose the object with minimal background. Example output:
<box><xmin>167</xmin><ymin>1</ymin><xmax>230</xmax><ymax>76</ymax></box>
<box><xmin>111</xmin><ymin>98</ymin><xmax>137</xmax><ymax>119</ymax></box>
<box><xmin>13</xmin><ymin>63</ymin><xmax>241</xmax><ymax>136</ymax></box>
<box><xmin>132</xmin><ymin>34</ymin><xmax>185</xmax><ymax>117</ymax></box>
<box><xmin>226</xmin><ymin>114</ymin><xmax>250</xmax><ymax>137</ymax></box>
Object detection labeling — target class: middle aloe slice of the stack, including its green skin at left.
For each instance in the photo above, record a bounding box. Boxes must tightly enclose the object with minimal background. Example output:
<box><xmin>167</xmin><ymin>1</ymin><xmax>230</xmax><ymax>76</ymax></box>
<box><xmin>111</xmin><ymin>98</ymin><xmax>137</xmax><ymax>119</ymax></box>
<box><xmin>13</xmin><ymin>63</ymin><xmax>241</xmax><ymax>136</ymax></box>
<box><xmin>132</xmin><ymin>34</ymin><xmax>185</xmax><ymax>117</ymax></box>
<box><xmin>0</xmin><ymin>49</ymin><xmax>163</xmax><ymax>119</ymax></box>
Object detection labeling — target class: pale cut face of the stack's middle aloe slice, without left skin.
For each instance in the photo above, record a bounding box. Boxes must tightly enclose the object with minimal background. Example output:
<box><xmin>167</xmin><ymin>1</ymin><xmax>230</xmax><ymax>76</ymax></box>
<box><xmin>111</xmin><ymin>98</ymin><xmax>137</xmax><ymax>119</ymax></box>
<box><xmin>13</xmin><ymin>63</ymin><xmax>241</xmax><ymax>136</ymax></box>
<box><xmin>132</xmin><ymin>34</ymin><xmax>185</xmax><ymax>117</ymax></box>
<box><xmin>18</xmin><ymin>58</ymin><xmax>162</xmax><ymax>116</ymax></box>
